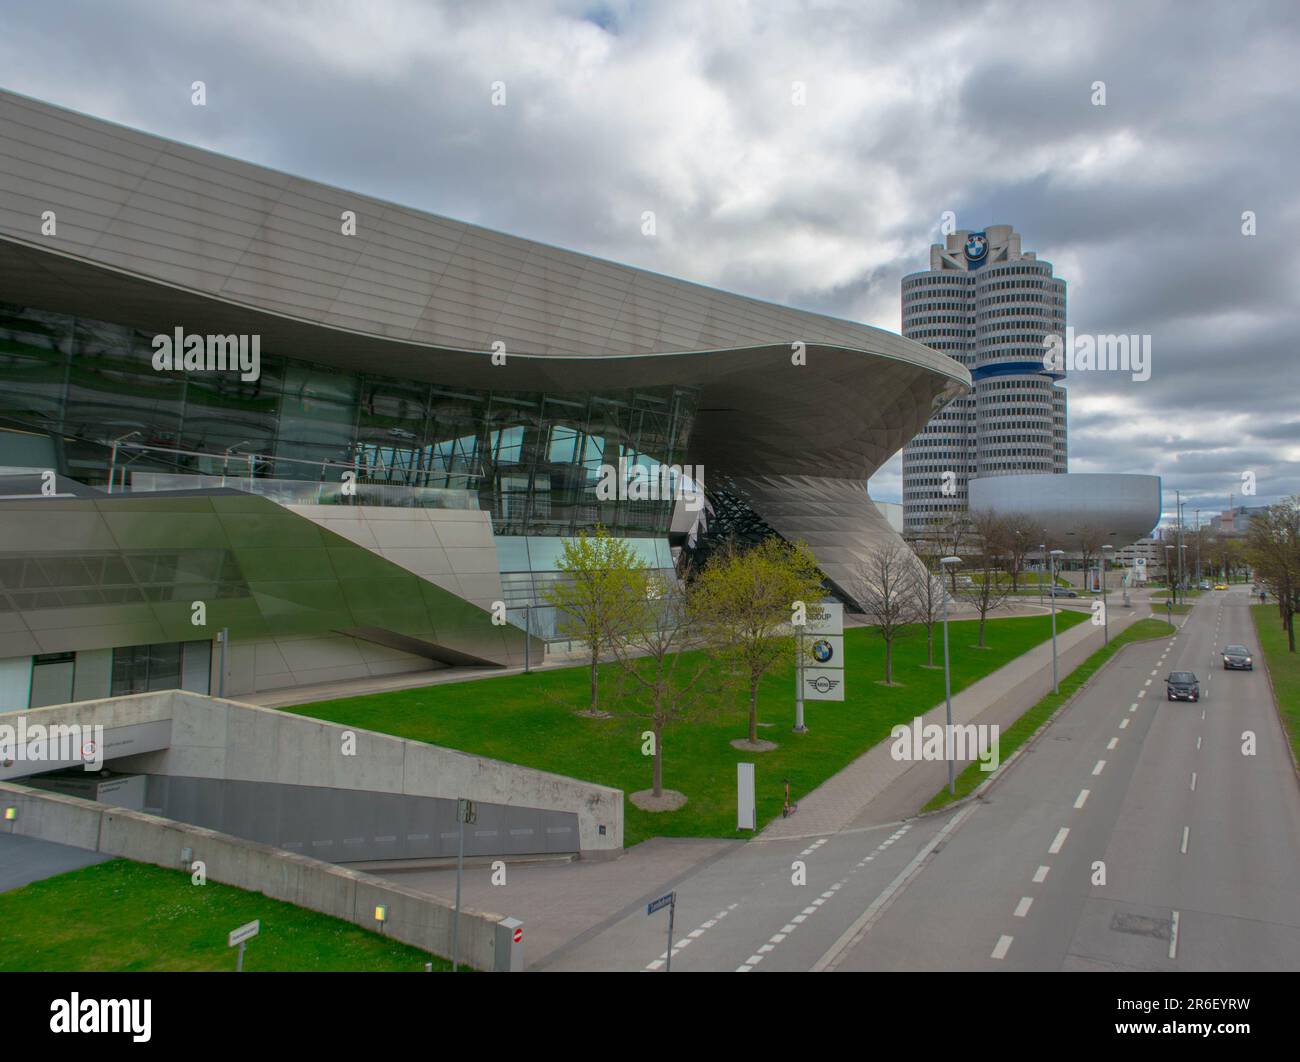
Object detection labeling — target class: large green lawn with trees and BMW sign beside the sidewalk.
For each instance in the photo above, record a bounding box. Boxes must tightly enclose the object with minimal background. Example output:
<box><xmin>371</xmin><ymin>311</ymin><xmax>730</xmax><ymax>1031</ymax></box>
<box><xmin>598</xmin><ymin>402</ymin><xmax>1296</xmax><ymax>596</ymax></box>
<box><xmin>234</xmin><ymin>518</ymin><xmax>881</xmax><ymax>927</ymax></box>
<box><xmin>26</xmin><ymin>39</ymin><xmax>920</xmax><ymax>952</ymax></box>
<box><xmin>283</xmin><ymin>612</ymin><xmax>1086</xmax><ymax>846</ymax></box>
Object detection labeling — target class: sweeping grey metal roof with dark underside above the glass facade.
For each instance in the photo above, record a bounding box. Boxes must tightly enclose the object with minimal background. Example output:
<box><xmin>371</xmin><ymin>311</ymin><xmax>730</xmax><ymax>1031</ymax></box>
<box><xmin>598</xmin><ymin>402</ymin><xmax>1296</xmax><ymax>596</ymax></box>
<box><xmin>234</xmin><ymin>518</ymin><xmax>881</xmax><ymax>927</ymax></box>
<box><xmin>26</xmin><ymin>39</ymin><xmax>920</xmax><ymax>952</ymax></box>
<box><xmin>0</xmin><ymin>85</ymin><xmax>970</xmax><ymax>478</ymax></box>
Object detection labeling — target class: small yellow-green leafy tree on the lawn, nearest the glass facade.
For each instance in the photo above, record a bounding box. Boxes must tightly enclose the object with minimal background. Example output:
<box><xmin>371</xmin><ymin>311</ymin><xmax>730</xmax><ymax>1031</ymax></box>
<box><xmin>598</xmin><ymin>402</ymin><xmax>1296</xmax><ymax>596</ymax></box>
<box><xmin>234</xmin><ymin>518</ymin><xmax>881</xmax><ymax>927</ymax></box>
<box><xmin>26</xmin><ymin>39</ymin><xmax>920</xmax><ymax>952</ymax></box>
<box><xmin>543</xmin><ymin>526</ymin><xmax>649</xmax><ymax>715</ymax></box>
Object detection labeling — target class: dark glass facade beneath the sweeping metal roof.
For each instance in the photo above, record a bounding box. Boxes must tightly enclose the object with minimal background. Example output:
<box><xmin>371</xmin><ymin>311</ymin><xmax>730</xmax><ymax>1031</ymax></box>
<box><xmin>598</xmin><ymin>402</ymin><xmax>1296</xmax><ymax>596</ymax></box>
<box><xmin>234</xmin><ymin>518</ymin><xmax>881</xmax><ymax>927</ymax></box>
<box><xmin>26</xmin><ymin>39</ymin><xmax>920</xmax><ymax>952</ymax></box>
<box><xmin>0</xmin><ymin>303</ymin><xmax>697</xmax><ymax>537</ymax></box>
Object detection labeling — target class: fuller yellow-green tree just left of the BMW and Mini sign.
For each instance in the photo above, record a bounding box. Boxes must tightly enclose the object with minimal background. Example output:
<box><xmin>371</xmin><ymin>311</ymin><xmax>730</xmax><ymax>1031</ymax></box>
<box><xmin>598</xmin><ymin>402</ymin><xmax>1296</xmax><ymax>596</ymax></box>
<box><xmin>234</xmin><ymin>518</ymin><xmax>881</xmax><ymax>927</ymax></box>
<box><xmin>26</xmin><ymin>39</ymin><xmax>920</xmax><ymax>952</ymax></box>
<box><xmin>692</xmin><ymin>536</ymin><xmax>826</xmax><ymax>745</ymax></box>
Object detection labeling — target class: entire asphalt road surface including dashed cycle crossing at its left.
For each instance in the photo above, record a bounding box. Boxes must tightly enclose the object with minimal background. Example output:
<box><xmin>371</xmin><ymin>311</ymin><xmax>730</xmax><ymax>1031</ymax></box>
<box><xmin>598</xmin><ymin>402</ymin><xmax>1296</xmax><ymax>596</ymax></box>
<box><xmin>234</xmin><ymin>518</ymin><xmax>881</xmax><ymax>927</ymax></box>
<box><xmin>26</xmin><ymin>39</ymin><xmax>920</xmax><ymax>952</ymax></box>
<box><xmin>545</xmin><ymin>590</ymin><xmax>1300</xmax><ymax>972</ymax></box>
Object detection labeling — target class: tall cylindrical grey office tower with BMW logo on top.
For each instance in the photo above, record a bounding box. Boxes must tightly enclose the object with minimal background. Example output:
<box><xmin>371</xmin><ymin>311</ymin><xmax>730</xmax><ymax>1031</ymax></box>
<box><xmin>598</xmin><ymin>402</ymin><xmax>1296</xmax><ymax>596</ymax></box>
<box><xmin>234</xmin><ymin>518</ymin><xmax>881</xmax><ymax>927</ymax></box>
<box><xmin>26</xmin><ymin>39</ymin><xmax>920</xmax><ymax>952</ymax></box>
<box><xmin>902</xmin><ymin>225</ymin><xmax>1067</xmax><ymax>534</ymax></box>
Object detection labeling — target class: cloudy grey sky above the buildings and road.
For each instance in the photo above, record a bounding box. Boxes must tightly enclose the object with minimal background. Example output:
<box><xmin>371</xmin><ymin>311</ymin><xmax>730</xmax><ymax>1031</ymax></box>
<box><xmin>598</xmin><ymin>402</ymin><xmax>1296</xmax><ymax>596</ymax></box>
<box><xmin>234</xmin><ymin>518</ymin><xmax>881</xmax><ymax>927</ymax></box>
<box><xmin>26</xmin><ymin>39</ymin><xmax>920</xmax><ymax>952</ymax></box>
<box><xmin>0</xmin><ymin>0</ymin><xmax>1300</xmax><ymax>519</ymax></box>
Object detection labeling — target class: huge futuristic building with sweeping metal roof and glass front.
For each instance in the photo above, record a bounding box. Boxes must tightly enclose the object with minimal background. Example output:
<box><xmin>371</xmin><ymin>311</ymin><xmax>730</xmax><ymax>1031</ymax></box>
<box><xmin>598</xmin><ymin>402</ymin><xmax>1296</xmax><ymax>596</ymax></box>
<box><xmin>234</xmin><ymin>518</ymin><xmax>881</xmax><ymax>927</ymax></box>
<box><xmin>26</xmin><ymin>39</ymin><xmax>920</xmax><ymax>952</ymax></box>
<box><xmin>0</xmin><ymin>92</ymin><xmax>970</xmax><ymax>710</ymax></box>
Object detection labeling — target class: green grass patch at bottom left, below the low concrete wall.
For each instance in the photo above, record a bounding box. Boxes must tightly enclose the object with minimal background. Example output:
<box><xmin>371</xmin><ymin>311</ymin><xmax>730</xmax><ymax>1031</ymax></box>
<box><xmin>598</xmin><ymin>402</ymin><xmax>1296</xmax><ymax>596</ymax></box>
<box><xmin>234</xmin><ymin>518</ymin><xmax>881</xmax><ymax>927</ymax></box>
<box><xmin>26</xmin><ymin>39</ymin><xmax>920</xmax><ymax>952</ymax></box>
<box><xmin>0</xmin><ymin>859</ymin><xmax>451</xmax><ymax>972</ymax></box>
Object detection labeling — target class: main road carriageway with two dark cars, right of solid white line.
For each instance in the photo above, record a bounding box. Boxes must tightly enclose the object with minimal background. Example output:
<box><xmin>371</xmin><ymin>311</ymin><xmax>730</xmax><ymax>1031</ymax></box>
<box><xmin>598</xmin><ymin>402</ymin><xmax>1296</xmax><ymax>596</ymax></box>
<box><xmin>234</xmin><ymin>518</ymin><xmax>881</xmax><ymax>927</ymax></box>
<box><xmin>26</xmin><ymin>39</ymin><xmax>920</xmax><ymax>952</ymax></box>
<box><xmin>833</xmin><ymin>590</ymin><xmax>1300</xmax><ymax>971</ymax></box>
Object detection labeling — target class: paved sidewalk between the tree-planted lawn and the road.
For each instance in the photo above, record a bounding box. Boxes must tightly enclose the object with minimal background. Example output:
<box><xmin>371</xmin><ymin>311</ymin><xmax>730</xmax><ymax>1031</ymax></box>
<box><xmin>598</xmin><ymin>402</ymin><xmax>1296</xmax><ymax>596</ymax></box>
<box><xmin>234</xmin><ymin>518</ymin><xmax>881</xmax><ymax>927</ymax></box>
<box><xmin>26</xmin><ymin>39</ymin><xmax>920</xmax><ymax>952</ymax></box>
<box><xmin>757</xmin><ymin>601</ymin><xmax>1151</xmax><ymax>841</ymax></box>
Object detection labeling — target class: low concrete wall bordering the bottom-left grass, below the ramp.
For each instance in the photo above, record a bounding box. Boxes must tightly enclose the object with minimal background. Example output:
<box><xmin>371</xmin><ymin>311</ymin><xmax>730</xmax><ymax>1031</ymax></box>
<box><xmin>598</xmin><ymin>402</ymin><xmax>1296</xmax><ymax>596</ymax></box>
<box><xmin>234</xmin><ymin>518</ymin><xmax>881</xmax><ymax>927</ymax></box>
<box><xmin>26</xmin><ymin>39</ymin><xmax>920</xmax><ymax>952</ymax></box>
<box><xmin>0</xmin><ymin>783</ymin><xmax>502</xmax><ymax>970</ymax></box>
